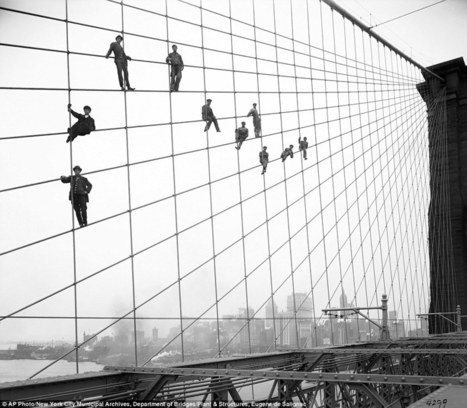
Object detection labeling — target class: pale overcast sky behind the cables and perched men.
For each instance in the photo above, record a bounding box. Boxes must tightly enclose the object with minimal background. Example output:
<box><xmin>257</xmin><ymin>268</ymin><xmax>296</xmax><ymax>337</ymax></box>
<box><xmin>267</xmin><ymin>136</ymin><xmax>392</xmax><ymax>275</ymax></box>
<box><xmin>0</xmin><ymin>0</ymin><xmax>467</xmax><ymax>372</ymax></box>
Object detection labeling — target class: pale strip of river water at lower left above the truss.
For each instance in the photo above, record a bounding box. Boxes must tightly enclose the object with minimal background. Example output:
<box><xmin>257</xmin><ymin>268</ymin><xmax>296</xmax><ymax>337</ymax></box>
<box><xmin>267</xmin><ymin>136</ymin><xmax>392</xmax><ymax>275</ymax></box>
<box><xmin>0</xmin><ymin>360</ymin><xmax>104</xmax><ymax>382</ymax></box>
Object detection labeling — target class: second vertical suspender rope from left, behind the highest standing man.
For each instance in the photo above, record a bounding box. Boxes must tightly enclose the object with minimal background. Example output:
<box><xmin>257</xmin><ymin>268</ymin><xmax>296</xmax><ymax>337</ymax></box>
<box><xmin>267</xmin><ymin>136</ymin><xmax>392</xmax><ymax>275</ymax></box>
<box><xmin>120</xmin><ymin>0</ymin><xmax>138</xmax><ymax>366</ymax></box>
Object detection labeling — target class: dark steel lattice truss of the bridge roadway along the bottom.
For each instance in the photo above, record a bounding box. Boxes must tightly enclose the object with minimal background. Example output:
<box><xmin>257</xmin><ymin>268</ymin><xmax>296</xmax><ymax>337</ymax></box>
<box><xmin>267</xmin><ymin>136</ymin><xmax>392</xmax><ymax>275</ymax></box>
<box><xmin>0</xmin><ymin>332</ymin><xmax>467</xmax><ymax>408</ymax></box>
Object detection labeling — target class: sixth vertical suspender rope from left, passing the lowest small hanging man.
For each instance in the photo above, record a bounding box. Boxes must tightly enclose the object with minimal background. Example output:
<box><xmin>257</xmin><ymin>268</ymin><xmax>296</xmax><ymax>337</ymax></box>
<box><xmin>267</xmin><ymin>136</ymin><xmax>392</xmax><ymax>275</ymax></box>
<box><xmin>252</xmin><ymin>0</ymin><xmax>278</xmax><ymax>350</ymax></box>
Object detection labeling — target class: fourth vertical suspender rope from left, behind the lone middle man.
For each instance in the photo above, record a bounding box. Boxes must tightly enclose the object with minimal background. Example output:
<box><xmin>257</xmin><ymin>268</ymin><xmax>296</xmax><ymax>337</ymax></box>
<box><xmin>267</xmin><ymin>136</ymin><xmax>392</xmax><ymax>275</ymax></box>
<box><xmin>200</xmin><ymin>0</ymin><xmax>221</xmax><ymax>357</ymax></box>
